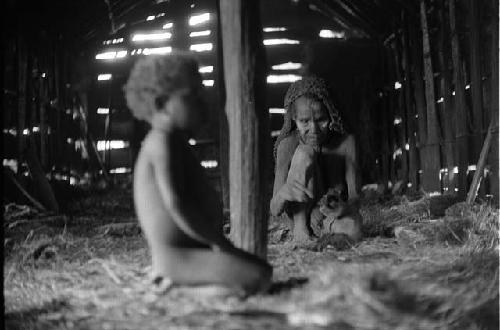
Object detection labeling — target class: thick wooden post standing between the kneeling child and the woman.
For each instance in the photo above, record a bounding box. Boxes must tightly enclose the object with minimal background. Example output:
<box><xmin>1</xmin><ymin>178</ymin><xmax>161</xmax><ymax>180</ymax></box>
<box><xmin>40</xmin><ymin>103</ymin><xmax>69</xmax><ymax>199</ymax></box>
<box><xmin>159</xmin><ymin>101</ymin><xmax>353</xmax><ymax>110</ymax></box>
<box><xmin>220</xmin><ymin>0</ymin><xmax>270</xmax><ymax>258</ymax></box>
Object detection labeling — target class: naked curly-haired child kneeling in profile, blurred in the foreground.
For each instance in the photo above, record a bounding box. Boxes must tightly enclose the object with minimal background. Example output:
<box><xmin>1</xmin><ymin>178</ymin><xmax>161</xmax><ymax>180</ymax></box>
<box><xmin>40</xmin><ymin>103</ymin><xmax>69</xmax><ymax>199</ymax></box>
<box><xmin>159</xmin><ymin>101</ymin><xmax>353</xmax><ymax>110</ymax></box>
<box><xmin>124</xmin><ymin>53</ymin><xmax>272</xmax><ymax>293</ymax></box>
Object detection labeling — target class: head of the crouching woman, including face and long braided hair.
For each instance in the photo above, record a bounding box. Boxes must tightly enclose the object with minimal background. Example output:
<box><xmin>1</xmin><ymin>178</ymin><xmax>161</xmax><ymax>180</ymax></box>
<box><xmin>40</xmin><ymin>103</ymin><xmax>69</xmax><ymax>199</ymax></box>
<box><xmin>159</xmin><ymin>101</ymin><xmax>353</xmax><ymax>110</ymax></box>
<box><xmin>275</xmin><ymin>76</ymin><xmax>345</xmax><ymax>155</ymax></box>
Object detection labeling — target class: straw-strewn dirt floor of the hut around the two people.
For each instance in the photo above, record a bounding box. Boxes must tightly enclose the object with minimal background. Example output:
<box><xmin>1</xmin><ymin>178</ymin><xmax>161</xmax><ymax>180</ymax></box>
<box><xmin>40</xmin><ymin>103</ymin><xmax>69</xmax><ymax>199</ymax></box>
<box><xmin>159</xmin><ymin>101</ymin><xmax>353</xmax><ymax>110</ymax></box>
<box><xmin>4</xmin><ymin>190</ymin><xmax>499</xmax><ymax>330</ymax></box>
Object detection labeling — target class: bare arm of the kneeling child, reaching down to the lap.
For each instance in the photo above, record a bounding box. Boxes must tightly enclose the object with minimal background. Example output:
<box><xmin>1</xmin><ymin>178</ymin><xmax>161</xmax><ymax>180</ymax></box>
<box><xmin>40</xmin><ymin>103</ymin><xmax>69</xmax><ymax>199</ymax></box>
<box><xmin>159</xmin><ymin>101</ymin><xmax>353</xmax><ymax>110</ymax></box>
<box><xmin>147</xmin><ymin>134</ymin><xmax>232</xmax><ymax>248</ymax></box>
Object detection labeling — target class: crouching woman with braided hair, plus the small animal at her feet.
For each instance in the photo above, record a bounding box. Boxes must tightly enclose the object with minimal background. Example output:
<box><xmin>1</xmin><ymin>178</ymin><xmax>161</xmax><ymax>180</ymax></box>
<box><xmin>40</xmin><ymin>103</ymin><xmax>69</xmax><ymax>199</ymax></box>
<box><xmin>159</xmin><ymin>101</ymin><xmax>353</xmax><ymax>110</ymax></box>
<box><xmin>271</xmin><ymin>77</ymin><xmax>362</xmax><ymax>245</ymax></box>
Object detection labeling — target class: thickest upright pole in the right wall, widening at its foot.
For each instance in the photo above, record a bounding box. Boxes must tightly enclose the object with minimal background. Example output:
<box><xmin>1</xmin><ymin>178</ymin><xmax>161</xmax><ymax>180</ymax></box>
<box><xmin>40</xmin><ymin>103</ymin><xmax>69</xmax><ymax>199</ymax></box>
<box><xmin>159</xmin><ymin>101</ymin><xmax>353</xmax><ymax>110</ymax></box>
<box><xmin>420</xmin><ymin>0</ymin><xmax>441</xmax><ymax>192</ymax></box>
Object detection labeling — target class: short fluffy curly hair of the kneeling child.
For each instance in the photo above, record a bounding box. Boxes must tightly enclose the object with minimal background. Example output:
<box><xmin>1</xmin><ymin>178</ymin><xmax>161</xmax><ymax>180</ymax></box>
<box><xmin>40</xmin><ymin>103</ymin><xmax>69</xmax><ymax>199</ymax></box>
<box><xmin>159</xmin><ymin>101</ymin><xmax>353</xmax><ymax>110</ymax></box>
<box><xmin>123</xmin><ymin>52</ymin><xmax>202</xmax><ymax>120</ymax></box>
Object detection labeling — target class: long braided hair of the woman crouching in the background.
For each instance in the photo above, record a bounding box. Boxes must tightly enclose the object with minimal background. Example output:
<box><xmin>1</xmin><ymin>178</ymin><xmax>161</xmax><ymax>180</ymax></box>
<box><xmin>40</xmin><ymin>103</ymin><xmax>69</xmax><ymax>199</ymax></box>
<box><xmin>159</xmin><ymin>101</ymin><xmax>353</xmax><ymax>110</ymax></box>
<box><xmin>274</xmin><ymin>76</ymin><xmax>345</xmax><ymax>158</ymax></box>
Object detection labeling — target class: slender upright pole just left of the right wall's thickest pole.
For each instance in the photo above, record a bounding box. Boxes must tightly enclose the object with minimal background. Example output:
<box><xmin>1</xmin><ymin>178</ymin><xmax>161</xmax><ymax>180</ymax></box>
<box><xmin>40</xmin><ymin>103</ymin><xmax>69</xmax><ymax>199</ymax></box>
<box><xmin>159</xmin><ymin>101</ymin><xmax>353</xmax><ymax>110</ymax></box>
<box><xmin>401</xmin><ymin>11</ymin><xmax>418</xmax><ymax>191</ymax></box>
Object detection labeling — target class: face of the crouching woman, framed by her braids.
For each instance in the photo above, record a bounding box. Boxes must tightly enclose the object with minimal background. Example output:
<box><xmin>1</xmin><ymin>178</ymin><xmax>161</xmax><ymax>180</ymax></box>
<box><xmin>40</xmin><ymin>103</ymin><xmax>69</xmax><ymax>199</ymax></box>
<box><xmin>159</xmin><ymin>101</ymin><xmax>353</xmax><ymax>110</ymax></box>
<box><xmin>293</xmin><ymin>96</ymin><xmax>330</xmax><ymax>146</ymax></box>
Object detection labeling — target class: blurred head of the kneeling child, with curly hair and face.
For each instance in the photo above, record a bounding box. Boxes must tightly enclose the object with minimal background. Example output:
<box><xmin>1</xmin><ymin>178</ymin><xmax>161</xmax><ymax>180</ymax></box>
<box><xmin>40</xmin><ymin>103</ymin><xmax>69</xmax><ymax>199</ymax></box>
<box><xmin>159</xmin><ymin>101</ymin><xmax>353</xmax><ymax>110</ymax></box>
<box><xmin>124</xmin><ymin>53</ymin><xmax>203</xmax><ymax>128</ymax></box>
